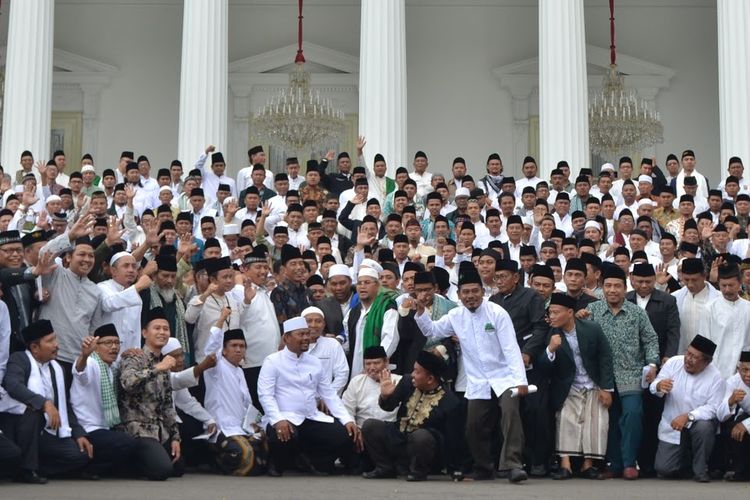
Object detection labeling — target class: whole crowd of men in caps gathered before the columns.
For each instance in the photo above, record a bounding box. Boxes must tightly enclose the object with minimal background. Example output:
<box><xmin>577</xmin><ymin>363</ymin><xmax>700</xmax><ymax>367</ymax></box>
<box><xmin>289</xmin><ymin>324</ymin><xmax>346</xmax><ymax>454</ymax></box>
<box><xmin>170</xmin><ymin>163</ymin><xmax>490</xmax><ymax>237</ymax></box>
<box><xmin>0</xmin><ymin>138</ymin><xmax>750</xmax><ymax>484</ymax></box>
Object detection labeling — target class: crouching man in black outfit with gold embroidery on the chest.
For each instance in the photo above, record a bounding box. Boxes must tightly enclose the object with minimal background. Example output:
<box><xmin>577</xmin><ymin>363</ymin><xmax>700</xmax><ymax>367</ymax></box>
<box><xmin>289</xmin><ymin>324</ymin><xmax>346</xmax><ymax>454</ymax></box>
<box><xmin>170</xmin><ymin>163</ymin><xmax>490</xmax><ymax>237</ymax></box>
<box><xmin>362</xmin><ymin>351</ymin><xmax>461</xmax><ymax>481</ymax></box>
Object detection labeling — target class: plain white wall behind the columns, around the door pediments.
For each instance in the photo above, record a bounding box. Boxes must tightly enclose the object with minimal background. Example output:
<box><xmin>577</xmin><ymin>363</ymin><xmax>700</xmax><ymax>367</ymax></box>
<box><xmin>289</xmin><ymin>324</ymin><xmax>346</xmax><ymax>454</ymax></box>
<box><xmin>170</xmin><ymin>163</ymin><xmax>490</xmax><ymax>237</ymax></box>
<box><xmin>0</xmin><ymin>0</ymin><xmax>722</xmax><ymax>184</ymax></box>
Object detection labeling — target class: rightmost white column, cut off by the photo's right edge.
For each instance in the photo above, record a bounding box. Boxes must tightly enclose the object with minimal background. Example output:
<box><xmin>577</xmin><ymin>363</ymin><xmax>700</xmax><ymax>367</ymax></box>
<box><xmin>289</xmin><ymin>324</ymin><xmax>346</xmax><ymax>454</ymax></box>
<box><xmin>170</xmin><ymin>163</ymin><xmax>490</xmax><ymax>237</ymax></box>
<box><xmin>720</xmin><ymin>0</ymin><xmax>750</xmax><ymax>178</ymax></box>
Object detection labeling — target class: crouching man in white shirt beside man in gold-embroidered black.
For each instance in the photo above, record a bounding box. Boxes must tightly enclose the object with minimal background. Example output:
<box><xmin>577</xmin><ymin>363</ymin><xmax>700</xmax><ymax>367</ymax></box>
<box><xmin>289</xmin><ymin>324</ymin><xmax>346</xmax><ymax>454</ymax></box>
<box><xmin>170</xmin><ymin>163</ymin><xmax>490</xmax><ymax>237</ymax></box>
<box><xmin>342</xmin><ymin>346</ymin><xmax>401</xmax><ymax>428</ymax></box>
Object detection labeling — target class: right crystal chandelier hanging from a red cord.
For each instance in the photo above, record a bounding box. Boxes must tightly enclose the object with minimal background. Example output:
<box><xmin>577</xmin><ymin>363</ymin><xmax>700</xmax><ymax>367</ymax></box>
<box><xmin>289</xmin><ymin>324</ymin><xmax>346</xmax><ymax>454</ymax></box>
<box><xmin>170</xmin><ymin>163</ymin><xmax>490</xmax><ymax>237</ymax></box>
<box><xmin>589</xmin><ymin>0</ymin><xmax>664</xmax><ymax>158</ymax></box>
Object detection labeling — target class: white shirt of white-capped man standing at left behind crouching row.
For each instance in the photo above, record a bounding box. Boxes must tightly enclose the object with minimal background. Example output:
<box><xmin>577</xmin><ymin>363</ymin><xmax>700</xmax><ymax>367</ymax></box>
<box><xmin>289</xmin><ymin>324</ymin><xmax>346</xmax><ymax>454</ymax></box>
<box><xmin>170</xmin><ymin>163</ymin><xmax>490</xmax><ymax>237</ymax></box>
<box><xmin>92</xmin><ymin>279</ymin><xmax>143</xmax><ymax>352</ymax></box>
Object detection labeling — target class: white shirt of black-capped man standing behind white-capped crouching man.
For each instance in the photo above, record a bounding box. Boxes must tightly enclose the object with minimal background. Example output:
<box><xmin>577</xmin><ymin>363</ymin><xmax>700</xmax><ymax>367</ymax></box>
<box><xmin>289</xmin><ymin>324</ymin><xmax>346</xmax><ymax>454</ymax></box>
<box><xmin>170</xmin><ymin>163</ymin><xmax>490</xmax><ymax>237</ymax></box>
<box><xmin>229</xmin><ymin>285</ymin><xmax>281</xmax><ymax>368</ymax></box>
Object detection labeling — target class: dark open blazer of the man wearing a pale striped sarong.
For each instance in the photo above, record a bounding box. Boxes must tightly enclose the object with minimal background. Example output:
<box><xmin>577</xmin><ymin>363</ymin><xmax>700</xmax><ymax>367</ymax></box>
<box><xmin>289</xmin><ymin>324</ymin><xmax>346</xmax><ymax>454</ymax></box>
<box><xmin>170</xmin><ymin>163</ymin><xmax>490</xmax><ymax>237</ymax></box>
<box><xmin>536</xmin><ymin>319</ymin><xmax>615</xmax><ymax>410</ymax></box>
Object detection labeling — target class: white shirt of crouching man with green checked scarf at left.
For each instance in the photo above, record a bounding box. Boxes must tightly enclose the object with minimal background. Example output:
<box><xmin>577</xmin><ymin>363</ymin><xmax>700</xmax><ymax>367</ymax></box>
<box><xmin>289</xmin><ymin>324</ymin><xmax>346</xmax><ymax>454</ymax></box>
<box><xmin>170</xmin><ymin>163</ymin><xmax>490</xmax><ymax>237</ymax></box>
<box><xmin>70</xmin><ymin>356</ymin><xmax>115</xmax><ymax>432</ymax></box>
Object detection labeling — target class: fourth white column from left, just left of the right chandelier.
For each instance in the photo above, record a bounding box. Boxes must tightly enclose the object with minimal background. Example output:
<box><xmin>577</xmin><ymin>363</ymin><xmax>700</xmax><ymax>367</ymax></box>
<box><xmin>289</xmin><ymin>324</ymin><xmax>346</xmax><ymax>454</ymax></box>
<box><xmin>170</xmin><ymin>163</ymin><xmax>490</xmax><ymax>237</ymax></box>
<box><xmin>539</xmin><ymin>0</ymin><xmax>590</xmax><ymax>179</ymax></box>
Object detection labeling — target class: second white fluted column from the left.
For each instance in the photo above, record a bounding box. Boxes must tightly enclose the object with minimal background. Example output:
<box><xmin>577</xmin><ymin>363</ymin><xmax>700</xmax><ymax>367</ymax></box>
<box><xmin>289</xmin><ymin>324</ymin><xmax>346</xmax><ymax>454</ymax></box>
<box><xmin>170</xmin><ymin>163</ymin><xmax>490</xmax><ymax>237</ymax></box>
<box><xmin>177</xmin><ymin>0</ymin><xmax>229</xmax><ymax>164</ymax></box>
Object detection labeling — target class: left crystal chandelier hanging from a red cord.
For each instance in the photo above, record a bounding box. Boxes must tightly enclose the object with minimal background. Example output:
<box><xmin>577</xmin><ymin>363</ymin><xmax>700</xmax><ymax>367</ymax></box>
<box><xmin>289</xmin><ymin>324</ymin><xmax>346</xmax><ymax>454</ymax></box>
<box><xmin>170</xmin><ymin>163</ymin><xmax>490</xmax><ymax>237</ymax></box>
<box><xmin>253</xmin><ymin>0</ymin><xmax>344</xmax><ymax>151</ymax></box>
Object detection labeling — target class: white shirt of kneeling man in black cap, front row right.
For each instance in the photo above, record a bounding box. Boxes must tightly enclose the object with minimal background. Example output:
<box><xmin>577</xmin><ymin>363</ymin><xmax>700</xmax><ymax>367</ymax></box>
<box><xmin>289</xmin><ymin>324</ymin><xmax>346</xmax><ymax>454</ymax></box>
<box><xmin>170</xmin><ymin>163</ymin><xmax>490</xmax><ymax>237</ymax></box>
<box><xmin>649</xmin><ymin>356</ymin><xmax>726</xmax><ymax>444</ymax></box>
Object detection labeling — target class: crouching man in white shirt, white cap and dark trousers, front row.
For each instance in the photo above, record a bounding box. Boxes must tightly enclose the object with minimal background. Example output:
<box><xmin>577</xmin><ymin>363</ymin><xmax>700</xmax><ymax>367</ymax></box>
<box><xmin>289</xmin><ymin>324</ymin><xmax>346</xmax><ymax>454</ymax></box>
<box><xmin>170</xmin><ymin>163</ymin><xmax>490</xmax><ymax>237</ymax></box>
<box><xmin>258</xmin><ymin>317</ymin><xmax>359</xmax><ymax>476</ymax></box>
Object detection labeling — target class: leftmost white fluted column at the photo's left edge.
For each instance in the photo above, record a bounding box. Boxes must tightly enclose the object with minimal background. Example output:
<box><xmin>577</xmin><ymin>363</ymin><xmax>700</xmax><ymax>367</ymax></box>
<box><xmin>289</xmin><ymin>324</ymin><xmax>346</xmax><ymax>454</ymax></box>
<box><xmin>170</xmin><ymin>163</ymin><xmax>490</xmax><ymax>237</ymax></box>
<box><xmin>1</xmin><ymin>0</ymin><xmax>55</xmax><ymax>177</ymax></box>
